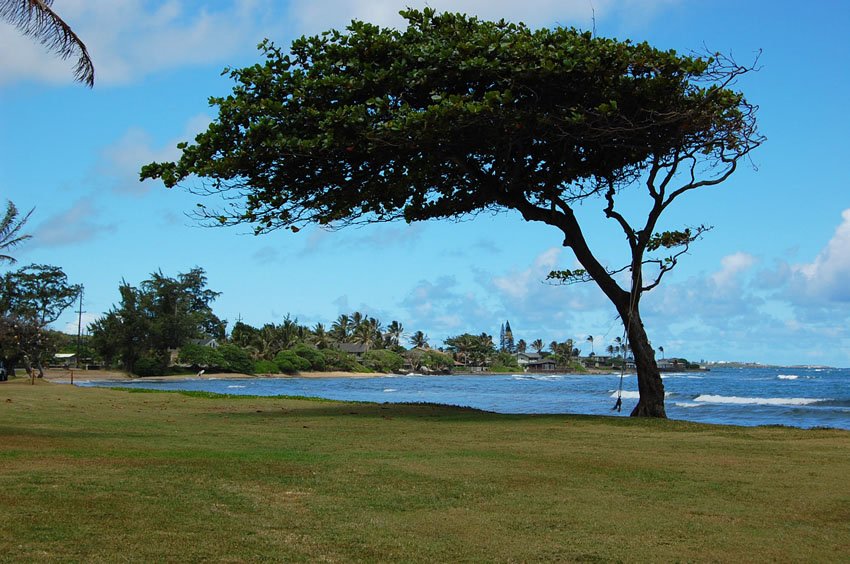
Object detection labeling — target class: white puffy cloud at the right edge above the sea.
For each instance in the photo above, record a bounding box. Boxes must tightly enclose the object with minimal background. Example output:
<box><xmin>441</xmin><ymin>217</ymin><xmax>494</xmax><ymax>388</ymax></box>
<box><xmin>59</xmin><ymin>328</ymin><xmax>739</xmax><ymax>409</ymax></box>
<box><xmin>791</xmin><ymin>209</ymin><xmax>850</xmax><ymax>302</ymax></box>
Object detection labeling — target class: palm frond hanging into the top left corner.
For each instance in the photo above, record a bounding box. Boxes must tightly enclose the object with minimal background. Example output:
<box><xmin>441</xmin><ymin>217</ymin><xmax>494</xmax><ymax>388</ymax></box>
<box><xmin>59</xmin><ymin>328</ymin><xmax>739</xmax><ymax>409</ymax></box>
<box><xmin>0</xmin><ymin>0</ymin><xmax>94</xmax><ymax>88</ymax></box>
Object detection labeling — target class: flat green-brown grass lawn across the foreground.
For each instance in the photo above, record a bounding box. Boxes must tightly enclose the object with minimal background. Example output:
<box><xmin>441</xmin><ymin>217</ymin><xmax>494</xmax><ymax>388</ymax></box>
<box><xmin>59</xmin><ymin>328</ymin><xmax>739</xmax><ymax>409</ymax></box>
<box><xmin>0</xmin><ymin>379</ymin><xmax>850</xmax><ymax>562</ymax></box>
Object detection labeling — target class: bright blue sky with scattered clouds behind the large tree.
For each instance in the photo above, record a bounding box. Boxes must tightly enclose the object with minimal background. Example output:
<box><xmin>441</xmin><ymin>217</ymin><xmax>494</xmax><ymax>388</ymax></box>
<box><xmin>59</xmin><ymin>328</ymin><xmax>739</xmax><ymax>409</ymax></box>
<box><xmin>0</xmin><ymin>0</ymin><xmax>850</xmax><ymax>367</ymax></box>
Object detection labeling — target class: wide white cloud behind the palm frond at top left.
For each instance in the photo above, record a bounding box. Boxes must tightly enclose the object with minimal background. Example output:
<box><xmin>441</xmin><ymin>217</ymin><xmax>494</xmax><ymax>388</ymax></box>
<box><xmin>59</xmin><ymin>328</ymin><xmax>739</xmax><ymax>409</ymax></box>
<box><xmin>0</xmin><ymin>0</ymin><xmax>268</xmax><ymax>86</ymax></box>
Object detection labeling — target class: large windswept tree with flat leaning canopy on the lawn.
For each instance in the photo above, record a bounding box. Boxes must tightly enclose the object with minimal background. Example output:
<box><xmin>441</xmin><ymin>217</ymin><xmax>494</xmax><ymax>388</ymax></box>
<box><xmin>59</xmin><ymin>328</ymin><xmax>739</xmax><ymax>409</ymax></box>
<box><xmin>141</xmin><ymin>9</ymin><xmax>763</xmax><ymax>417</ymax></box>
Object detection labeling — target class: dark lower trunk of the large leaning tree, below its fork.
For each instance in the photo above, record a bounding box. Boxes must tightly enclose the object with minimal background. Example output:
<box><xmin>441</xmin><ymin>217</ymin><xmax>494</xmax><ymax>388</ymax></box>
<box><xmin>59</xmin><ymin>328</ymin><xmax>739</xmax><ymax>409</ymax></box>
<box><xmin>617</xmin><ymin>304</ymin><xmax>667</xmax><ymax>418</ymax></box>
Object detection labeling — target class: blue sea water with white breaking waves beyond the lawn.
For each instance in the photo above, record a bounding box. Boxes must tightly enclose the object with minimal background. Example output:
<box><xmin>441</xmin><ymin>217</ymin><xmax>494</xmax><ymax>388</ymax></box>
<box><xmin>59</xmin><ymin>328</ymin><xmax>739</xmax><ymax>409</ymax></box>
<box><xmin>78</xmin><ymin>368</ymin><xmax>850</xmax><ymax>429</ymax></box>
